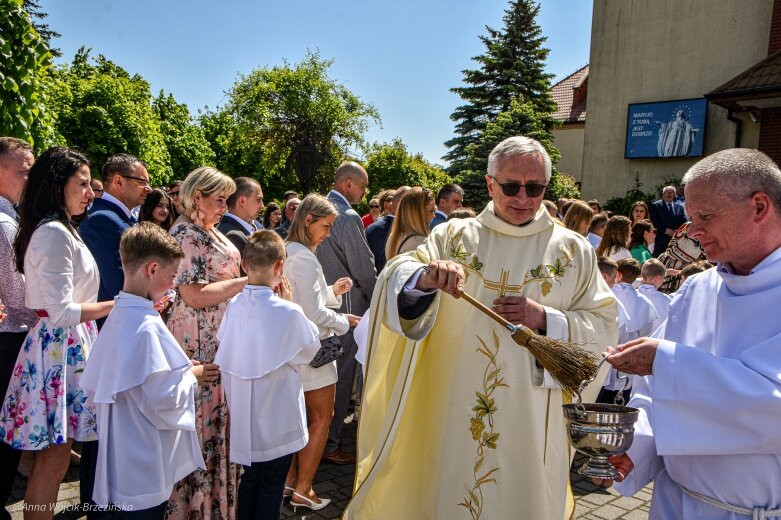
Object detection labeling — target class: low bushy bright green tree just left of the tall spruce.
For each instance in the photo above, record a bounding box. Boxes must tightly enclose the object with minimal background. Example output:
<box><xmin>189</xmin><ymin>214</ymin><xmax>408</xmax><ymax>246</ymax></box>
<box><xmin>366</xmin><ymin>138</ymin><xmax>452</xmax><ymax>194</ymax></box>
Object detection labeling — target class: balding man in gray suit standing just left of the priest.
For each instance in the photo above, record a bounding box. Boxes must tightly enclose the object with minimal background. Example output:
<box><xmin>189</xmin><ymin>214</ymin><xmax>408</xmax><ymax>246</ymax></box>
<box><xmin>316</xmin><ymin>161</ymin><xmax>377</xmax><ymax>464</ymax></box>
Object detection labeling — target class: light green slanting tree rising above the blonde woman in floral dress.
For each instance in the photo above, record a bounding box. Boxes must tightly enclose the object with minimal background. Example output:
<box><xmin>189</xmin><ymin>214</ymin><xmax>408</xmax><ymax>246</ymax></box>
<box><xmin>152</xmin><ymin>90</ymin><xmax>215</xmax><ymax>178</ymax></box>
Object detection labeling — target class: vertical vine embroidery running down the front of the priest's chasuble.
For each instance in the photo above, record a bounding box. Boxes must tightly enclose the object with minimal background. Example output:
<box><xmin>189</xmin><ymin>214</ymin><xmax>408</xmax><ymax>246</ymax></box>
<box><xmin>458</xmin><ymin>331</ymin><xmax>509</xmax><ymax>520</ymax></box>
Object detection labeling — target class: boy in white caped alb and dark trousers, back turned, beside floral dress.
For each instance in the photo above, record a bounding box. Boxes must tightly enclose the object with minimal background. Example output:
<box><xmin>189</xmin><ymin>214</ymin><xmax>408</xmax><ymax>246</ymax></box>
<box><xmin>214</xmin><ymin>230</ymin><xmax>320</xmax><ymax>520</ymax></box>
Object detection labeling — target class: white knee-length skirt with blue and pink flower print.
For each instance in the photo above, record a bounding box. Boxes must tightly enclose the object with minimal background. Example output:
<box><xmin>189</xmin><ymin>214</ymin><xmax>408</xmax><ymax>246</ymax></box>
<box><xmin>0</xmin><ymin>318</ymin><xmax>98</xmax><ymax>450</ymax></box>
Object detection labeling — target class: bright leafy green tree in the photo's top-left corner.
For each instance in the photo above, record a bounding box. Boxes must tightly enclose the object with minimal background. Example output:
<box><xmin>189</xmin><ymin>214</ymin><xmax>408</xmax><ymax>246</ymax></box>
<box><xmin>0</xmin><ymin>0</ymin><xmax>57</xmax><ymax>150</ymax></box>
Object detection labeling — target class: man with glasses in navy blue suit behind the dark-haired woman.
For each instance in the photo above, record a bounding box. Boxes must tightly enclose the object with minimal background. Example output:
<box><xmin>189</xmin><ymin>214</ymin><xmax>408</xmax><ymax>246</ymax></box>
<box><xmin>79</xmin><ymin>153</ymin><xmax>152</xmax><ymax>301</ymax></box>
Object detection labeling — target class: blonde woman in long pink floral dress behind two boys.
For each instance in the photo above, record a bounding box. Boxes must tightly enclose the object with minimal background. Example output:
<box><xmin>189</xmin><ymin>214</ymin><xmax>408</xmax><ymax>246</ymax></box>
<box><xmin>166</xmin><ymin>167</ymin><xmax>247</xmax><ymax>520</ymax></box>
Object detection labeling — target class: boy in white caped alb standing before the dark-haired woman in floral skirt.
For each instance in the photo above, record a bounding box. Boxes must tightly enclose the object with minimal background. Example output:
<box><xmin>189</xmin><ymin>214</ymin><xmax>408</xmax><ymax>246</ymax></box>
<box><xmin>81</xmin><ymin>222</ymin><xmax>204</xmax><ymax>520</ymax></box>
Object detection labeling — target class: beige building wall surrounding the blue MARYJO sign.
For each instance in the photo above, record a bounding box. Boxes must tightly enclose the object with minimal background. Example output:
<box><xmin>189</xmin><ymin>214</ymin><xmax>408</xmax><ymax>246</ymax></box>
<box><xmin>582</xmin><ymin>0</ymin><xmax>773</xmax><ymax>200</ymax></box>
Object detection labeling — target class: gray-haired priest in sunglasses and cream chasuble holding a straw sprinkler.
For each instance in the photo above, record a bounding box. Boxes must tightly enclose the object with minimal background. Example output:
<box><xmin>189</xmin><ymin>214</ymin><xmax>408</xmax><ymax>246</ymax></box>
<box><xmin>343</xmin><ymin>137</ymin><xmax>617</xmax><ymax>520</ymax></box>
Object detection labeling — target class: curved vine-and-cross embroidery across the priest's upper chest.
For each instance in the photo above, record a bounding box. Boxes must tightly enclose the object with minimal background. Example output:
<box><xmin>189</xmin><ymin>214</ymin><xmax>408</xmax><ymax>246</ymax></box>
<box><xmin>446</xmin><ymin>224</ymin><xmax>575</xmax><ymax>296</ymax></box>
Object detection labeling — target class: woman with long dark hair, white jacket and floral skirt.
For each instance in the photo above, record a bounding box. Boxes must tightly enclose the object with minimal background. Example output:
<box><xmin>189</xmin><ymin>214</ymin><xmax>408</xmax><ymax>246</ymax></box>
<box><xmin>0</xmin><ymin>147</ymin><xmax>114</xmax><ymax>520</ymax></box>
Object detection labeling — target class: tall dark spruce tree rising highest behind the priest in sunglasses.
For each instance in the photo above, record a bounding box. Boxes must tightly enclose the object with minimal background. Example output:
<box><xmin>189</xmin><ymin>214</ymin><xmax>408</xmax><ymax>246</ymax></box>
<box><xmin>444</xmin><ymin>0</ymin><xmax>556</xmax><ymax>175</ymax></box>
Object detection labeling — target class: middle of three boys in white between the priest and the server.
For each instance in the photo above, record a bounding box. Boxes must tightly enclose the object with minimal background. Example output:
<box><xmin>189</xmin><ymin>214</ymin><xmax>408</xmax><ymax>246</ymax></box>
<box><xmin>597</xmin><ymin>258</ymin><xmax>659</xmax><ymax>403</ymax></box>
